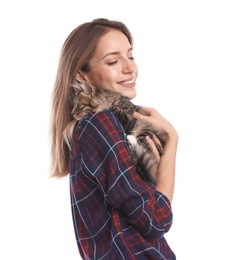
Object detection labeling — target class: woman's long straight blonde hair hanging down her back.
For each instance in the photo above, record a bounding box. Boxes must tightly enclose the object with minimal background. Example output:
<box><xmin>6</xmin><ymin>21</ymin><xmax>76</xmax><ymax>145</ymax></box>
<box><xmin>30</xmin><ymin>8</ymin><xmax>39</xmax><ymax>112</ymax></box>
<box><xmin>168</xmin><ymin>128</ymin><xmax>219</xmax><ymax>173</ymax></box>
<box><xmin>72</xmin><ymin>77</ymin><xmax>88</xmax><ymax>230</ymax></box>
<box><xmin>49</xmin><ymin>18</ymin><xmax>133</xmax><ymax>178</ymax></box>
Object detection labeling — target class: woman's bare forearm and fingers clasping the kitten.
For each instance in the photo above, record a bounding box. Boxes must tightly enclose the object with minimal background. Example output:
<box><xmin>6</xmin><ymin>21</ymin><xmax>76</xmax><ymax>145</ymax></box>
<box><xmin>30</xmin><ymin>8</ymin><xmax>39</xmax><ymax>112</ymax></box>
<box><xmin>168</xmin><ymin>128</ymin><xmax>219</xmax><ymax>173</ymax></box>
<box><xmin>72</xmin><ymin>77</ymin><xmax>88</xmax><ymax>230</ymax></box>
<box><xmin>134</xmin><ymin>107</ymin><xmax>178</xmax><ymax>202</ymax></box>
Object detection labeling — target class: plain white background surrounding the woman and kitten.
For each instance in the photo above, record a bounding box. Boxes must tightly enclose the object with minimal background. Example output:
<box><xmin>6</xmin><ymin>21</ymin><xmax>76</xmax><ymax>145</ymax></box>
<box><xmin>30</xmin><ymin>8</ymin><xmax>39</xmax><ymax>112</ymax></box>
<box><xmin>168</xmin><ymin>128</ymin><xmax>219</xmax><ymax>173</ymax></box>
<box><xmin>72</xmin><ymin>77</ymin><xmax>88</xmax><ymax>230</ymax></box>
<box><xmin>0</xmin><ymin>0</ymin><xmax>228</xmax><ymax>260</ymax></box>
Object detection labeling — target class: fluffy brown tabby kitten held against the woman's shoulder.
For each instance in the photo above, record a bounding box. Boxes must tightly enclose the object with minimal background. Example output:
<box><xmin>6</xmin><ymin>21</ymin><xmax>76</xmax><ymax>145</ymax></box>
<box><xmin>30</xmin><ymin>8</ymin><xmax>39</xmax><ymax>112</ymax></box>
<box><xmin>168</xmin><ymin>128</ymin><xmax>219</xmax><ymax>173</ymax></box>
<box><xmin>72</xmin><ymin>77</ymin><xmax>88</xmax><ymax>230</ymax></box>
<box><xmin>72</xmin><ymin>82</ymin><xmax>167</xmax><ymax>185</ymax></box>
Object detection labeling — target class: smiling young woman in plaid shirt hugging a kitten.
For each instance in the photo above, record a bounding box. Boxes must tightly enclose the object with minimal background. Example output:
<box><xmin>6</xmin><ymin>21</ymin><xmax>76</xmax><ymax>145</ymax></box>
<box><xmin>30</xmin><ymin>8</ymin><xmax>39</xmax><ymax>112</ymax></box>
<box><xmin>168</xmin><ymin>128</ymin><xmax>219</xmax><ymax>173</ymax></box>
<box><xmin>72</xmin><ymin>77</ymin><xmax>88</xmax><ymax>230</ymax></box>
<box><xmin>50</xmin><ymin>19</ymin><xmax>178</xmax><ymax>260</ymax></box>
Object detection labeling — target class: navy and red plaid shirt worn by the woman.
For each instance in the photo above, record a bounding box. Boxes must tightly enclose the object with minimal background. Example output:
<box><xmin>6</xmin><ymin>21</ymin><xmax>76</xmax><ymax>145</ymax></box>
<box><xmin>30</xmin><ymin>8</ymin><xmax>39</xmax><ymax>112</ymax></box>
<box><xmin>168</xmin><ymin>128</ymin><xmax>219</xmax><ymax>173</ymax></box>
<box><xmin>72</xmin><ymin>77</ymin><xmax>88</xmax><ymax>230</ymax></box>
<box><xmin>70</xmin><ymin>111</ymin><xmax>176</xmax><ymax>260</ymax></box>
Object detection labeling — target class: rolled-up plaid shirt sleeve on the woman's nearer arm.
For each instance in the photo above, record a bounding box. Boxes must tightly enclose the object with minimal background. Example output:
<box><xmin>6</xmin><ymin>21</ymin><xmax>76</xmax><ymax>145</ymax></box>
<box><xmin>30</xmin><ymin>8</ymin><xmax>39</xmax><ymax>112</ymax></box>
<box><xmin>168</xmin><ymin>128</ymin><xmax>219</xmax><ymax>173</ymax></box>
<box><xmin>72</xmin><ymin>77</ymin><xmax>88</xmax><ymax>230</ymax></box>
<box><xmin>79</xmin><ymin>111</ymin><xmax>173</xmax><ymax>239</ymax></box>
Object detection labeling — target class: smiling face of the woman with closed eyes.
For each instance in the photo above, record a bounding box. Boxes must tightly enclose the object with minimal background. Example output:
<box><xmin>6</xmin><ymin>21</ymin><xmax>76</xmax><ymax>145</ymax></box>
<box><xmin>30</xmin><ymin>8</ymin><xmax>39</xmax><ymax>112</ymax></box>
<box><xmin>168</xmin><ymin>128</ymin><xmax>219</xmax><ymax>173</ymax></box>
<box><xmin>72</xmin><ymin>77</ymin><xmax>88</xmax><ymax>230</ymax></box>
<box><xmin>79</xmin><ymin>30</ymin><xmax>138</xmax><ymax>99</ymax></box>
